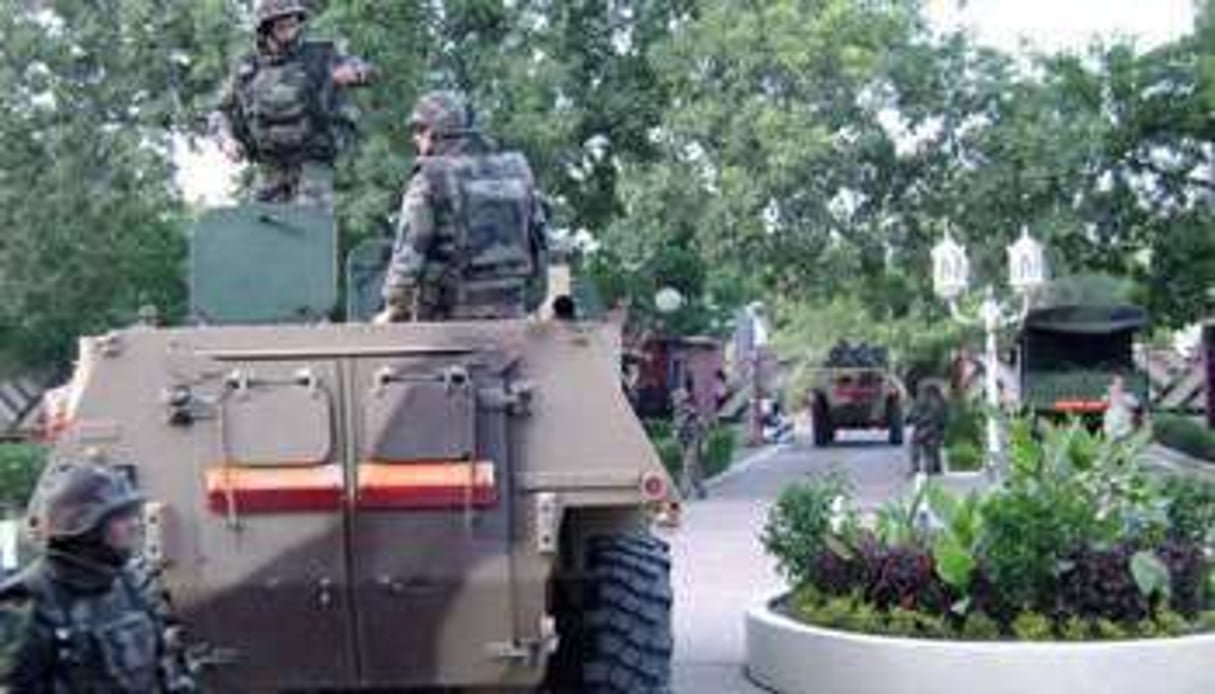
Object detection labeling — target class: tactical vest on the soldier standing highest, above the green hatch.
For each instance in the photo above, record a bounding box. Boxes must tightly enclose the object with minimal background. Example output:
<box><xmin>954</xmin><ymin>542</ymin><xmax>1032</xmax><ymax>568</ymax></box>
<box><xmin>237</xmin><ymin>43</ymin><xmax>335</xmax><ymax>162</ymax></box>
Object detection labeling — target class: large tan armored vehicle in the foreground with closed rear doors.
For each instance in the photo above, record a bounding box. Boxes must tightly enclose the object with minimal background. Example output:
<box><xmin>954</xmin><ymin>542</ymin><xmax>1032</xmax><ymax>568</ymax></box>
<box><xmin>34</xmin><ymin>205</ymin><xmax>672</xmax><ymax>693</ymax></box>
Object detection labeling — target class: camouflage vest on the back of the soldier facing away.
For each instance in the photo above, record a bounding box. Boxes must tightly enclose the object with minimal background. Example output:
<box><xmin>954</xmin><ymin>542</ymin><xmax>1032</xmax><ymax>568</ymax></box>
<box><xmin>419</xmin><ymin>152</ymin><xmax>543</xmax><ymax>318</ymax></box>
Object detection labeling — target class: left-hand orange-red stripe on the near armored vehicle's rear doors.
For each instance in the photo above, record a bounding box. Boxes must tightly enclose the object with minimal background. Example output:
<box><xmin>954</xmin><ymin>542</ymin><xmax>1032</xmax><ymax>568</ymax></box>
<box><xmin>207</xmin><ymin>466</ymin><xmax>345</xmax><ymax>514</ymax></box>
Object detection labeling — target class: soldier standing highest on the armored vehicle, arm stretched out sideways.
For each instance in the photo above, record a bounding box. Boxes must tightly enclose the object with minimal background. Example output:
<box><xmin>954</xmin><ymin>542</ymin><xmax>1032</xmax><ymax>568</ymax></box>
<box><xmin>211</xmin><ymin>0</ymin><xmax>372</xmax><ymax>207</ymax></box>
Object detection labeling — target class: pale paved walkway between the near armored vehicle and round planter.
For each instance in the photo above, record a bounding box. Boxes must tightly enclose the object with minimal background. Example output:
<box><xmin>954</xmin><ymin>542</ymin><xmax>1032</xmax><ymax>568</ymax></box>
<box><xmin>668</xmin><ymin>434</ymin><xmax>923</xmax><ymax>694</ymax></box>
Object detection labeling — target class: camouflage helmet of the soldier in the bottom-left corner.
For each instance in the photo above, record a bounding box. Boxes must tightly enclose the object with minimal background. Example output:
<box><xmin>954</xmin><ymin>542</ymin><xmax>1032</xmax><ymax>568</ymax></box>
<box><xmin>40</xmin><ymin>464</ymin><xmax>143</xmax><ymax>538</ymax></box>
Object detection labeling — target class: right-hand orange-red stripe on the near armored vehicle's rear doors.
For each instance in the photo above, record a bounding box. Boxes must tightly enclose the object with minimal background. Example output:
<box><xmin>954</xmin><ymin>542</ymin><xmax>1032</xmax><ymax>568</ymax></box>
<box><xmin>358</xmin><ymin>462</ymin><xmax>498</xmax><ymax>509</ymax></box>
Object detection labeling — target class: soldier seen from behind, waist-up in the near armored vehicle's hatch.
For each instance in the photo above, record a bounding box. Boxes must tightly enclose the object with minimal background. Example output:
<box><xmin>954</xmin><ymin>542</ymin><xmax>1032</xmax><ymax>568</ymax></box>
<box><xmin>377</xmin><ymin>91</ymin><xmax>547</xmax><ymax>322</ymax></box>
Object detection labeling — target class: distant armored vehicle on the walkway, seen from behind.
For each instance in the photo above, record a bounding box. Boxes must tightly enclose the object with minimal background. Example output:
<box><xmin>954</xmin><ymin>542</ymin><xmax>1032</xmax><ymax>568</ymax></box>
<box><xmin>810</xmin><ymin>342</ymin><xmax>905</xmax><ymax>447</ymax></box>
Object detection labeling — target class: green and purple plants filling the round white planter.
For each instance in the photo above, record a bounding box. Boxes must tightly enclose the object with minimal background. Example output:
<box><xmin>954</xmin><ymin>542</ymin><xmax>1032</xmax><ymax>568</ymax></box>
<box><xmin>764</xmin><ymin>419</ymin><xmax>1215</xmax><ymax>641</ymax></box>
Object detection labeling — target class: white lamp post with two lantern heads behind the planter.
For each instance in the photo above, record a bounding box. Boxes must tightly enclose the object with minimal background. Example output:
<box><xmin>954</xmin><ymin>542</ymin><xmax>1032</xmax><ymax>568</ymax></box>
<box><xmin>932</xmin><ymin>228</ymin><xmax>1046</xmax><ymax>476</ymax></box>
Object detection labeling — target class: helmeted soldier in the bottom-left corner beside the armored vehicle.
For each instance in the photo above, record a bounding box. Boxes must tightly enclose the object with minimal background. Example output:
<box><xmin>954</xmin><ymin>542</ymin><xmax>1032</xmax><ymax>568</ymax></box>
<box><xmin>0</xmin><ymin>466</ymin><xmax>194</xmax><ymax>694</ymax></box>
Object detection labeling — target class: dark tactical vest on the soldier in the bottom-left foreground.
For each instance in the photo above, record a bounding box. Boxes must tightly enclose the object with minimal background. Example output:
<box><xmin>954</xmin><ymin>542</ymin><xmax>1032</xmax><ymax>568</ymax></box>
<box><xmin>27</xmin><ymin>572</ymin><xmax>160</xmax><ymax>694</ymax></box>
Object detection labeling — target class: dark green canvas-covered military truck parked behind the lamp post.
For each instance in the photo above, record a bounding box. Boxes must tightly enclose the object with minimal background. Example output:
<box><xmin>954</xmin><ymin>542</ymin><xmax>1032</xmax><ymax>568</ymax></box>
<box><xmin>1019</xmin><ymin>305</ymin><xmax>1148</xmax><ymax>418</ymax></box>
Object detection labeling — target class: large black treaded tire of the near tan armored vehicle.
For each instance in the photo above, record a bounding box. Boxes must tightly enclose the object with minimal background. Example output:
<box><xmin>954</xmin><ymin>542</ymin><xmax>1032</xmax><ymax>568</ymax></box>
<box><xmin>578</xmin><ymin>534</ymin><xmax>674</xmax><ymax>694</ymax></box>
